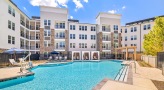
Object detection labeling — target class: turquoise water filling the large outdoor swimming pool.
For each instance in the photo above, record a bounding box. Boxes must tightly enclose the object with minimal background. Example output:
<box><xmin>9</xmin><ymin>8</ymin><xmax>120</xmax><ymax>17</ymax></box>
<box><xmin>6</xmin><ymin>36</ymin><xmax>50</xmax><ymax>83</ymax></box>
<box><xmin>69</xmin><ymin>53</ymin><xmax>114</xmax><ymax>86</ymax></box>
<box><xmin>0</xmin><ymin>61</ymin><xmax>122</xmax><ymax>90</ymax></box>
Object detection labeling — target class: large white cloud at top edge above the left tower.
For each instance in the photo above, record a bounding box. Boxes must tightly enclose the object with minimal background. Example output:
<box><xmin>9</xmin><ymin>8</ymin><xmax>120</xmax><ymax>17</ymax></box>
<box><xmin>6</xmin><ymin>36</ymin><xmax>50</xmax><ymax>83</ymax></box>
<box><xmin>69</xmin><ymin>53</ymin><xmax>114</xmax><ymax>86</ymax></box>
<box><xmin>30</xmin><ymin>0</ymin><xmax>68</xmax><ymax>7</ymax></box>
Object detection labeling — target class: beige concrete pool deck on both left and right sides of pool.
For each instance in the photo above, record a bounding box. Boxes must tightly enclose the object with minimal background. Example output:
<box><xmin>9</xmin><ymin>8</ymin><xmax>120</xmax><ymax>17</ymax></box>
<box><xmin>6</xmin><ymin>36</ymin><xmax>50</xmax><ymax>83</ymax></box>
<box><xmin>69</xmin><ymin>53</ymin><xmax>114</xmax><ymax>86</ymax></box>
<box><xmin>0</xmin><ymin>62</ymin><xmax>164</xmax><ymax>90</ymax></box>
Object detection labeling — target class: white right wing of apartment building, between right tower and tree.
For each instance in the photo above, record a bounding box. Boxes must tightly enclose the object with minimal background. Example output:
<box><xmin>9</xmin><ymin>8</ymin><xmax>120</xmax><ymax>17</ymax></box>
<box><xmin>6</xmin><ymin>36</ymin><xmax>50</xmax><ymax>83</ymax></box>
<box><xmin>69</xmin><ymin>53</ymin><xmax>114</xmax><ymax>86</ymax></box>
<box><xmin>121</xmin><ymin>17</ymin><xmax>158</xmax><ymax>52</ymax></box>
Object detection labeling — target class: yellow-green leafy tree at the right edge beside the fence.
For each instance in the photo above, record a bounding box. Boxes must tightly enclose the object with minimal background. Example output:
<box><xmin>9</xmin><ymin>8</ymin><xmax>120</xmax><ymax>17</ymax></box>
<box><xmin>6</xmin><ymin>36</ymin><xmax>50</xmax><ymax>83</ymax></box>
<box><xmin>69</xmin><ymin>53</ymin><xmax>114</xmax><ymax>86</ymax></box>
<box><xmin>143</xmin><ymin>17</ymin><xmax>164</xmax><ymax>56</ymax></box>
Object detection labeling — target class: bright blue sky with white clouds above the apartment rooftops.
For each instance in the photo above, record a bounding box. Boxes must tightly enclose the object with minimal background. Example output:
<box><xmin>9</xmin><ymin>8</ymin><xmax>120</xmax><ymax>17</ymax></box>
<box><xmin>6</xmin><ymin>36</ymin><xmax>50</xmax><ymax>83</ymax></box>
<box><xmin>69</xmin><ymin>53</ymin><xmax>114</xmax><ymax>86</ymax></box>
<box><xmin>12</xmin><ymin>0</ymin><xmax>164</xmax><ymax>25</ymax></box>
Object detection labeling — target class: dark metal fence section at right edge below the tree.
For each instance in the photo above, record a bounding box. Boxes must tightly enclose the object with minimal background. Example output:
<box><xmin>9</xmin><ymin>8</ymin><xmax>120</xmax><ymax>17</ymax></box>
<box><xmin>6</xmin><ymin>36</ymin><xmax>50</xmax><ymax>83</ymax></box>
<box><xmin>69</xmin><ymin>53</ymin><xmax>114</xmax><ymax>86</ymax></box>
<box><xmin>157</xmin><ymin>52</ymin><xmax>164</xmax><ymax>69</ymax></box>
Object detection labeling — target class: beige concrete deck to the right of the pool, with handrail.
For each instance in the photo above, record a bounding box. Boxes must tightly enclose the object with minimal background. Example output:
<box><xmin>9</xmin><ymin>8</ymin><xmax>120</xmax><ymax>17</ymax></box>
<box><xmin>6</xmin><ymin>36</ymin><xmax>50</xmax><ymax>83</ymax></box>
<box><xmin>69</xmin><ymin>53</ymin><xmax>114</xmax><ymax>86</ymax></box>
<box><xmin>100</xmin><ymin>62</ymin><xmax>164</xmax><ymax>90</ymax></box>
